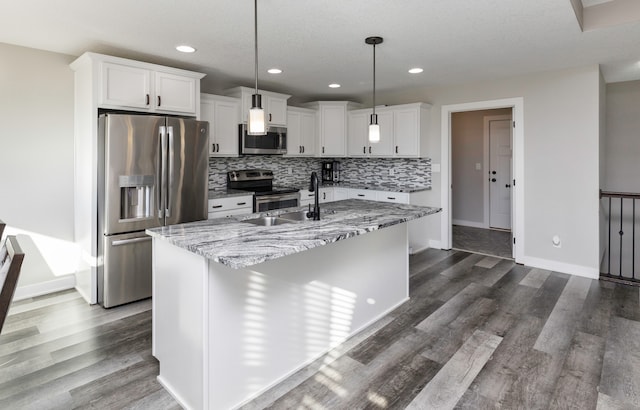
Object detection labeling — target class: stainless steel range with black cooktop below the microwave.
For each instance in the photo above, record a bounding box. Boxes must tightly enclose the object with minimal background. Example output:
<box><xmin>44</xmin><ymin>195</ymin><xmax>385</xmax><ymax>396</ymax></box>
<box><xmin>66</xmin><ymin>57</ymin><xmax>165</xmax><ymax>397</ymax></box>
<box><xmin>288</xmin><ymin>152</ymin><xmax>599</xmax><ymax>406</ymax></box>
<box><xmin>227</xmin><ymin>169</ymin><xmax>300</xmax><ymax>212</ymax></box>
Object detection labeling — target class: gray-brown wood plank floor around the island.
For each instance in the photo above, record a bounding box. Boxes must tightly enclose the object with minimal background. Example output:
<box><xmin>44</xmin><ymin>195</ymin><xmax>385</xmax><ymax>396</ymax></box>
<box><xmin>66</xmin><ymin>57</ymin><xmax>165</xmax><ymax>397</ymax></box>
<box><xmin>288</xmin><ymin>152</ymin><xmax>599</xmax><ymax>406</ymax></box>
<box><xmin>0</xmin><ymin>250</ymin><xmax>640</xmax><ymax>409</ymax></box>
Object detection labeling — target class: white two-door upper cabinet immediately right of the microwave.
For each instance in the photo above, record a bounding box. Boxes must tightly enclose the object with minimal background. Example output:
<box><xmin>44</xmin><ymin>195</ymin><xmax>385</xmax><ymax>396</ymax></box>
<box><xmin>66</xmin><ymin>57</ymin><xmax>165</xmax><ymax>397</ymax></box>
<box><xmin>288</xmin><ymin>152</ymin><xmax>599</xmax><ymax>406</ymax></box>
<box><xmin>287</xmin><ymin>107</ymin><xmax>316</xmax><ymax>157</ymax></box>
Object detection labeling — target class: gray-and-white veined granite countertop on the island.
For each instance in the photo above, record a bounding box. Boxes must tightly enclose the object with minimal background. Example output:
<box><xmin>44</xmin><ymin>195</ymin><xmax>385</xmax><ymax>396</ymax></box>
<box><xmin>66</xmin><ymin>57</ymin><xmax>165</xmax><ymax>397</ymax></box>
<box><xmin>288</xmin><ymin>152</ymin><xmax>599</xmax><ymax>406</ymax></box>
<box><xmin>146</xmin><ymin>199</ymin><xmax>441</xmax><ymax>269</ymax></box>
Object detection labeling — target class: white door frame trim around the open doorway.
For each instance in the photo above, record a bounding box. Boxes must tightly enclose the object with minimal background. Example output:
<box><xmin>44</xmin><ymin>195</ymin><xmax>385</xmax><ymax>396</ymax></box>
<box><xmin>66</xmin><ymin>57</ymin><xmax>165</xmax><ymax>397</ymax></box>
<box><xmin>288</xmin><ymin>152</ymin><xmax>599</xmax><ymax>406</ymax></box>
<box><xmin>440</xmin><ymin>97</ymin><xmax>525</xmax><ymax>263</ymax></box>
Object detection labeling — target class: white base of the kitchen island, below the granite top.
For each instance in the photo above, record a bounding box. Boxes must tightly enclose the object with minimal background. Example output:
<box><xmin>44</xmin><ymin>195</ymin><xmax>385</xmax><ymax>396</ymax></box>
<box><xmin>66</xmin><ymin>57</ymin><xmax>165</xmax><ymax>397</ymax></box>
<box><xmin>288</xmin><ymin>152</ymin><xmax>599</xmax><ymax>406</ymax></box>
<box><xmin>153</xmin><ymin>223</ymin><xmax>409</xmax><ymax>409</ymax></box>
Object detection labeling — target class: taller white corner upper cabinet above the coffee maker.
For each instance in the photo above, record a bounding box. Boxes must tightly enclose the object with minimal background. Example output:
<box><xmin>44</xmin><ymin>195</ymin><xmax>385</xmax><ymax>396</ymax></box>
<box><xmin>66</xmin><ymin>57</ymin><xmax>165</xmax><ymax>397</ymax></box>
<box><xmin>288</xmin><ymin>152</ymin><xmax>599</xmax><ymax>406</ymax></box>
<box><xmin>305</xmin><ymin>101</ymin><xmax>355</xmax><ymax>158</ymax></box>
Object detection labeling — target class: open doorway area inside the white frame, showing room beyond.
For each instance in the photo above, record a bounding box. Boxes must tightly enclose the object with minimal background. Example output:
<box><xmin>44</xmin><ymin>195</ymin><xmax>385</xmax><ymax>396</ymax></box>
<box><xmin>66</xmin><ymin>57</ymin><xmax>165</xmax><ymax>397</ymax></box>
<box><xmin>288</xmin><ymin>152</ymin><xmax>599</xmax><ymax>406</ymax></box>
<box><xmin>451</xmin><ymin>108</ymin><xmax>513</xmax><ymax>258</ymax></box>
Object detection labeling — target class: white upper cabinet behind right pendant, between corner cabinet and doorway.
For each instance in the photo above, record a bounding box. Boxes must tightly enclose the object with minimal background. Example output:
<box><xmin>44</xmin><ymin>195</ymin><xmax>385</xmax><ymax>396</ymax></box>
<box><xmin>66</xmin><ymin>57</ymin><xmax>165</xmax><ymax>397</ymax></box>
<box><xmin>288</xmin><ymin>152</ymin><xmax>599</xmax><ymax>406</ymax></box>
<box><xmin>347</xmin><ymin>103</ymin><xmax>431</xmax><ymax>158</ymax></box>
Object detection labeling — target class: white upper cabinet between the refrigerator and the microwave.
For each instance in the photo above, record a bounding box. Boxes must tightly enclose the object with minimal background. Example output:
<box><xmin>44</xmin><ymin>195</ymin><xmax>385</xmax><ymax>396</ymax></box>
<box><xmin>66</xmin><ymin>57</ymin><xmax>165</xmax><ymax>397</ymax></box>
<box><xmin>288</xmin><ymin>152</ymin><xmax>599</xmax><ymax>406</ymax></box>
<box><xmin>200</xmin><ymin>94</ymin><xmax>240</xmax><ymax>157</ymax></box>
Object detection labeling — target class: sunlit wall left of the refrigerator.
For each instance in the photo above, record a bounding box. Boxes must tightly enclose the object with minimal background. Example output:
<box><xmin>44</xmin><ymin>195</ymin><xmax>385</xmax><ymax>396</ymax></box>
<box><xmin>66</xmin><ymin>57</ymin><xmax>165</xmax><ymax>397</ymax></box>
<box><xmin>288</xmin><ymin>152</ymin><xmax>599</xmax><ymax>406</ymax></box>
<box><xmin>0</xmin><ymin>43</ymin><xmax>77</xmax><ymax>286</ymax></box>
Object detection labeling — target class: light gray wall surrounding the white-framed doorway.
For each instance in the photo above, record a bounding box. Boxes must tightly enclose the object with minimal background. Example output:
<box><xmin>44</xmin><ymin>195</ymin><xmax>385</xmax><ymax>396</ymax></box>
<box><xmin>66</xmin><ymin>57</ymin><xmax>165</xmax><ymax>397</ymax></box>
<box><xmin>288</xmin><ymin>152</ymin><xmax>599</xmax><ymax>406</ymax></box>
<box><xmin>377</xmin><ymin>65</ymin><xmax>600</xmax><ymax>277</ymax></box>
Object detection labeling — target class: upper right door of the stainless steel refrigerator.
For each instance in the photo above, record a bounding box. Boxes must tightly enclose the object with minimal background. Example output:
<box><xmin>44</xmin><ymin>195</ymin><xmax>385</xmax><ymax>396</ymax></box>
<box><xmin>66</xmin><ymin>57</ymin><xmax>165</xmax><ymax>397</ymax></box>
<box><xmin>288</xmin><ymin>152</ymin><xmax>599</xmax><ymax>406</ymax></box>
<box><xmin>165</xmin><ymin>117</ymin><xmax>209</xmax><ymax>225</ymax></box>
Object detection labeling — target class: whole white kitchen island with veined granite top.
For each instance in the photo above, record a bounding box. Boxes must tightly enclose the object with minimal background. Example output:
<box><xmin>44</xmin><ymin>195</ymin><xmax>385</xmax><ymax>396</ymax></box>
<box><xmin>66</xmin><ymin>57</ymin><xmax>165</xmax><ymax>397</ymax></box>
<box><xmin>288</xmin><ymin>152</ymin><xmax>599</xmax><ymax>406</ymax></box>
<box><xmin>147</xmin><ymin>200</ymin><xmax>439</xmax><ymax>409</ymax></box>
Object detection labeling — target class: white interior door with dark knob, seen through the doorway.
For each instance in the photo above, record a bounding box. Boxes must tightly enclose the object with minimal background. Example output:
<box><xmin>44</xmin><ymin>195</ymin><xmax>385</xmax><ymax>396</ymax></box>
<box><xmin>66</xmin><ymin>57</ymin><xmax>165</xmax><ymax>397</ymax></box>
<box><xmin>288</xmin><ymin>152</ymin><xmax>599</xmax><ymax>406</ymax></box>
<box><xmin>489</xmin><ymin>119</ymin><xmax>512</xmax><ymax>230</ymax></box>
